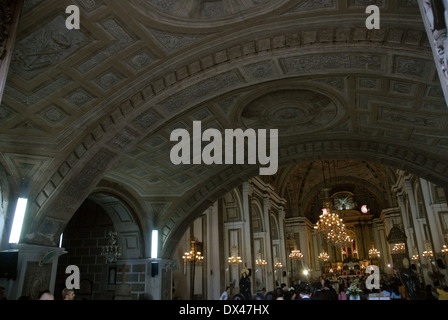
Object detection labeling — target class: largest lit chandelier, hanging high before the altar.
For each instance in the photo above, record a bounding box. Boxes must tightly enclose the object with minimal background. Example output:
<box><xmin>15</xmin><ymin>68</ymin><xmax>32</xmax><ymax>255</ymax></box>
<box><xmin>314</xmin><ymin>208</ymin><xmax>353</xmax><ymax>246</ymax></box>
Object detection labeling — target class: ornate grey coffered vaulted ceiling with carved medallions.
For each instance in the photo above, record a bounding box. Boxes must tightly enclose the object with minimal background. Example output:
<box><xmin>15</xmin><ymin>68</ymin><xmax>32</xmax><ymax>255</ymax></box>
<box><xmin>0</xmin><ymin>0</ymin><xmax>448</xmax><ymax>255</ymax></box>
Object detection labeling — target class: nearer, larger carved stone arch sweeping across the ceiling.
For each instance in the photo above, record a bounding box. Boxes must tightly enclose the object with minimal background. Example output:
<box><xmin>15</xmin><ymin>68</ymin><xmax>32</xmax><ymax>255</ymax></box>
<box><xmin>22</xmin><ymin>25</ymin><xmax>442</xmax><ymax>242</ymax></box>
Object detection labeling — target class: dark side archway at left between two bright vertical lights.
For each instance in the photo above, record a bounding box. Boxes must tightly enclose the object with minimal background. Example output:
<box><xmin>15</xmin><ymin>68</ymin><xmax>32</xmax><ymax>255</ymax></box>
<box><xmin>55</xmin><ymin>193</ymin><xmax>146</xmax><ymax>300</ymax></box>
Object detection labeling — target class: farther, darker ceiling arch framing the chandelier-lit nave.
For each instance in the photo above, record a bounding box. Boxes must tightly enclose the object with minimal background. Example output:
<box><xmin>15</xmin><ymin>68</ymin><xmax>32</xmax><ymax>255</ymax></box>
<box><xmin>161</xmin><ymin>139</ymin><xmax>448</xmax><ymax>257</ymax></box>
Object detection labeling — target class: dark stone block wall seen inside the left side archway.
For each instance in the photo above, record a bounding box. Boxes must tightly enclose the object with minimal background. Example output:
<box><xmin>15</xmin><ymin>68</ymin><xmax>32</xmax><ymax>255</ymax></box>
<box><xmin>55</xmin><ymin>200</ymin><xmax>147</xmax><ymax>300</ymax></box>
